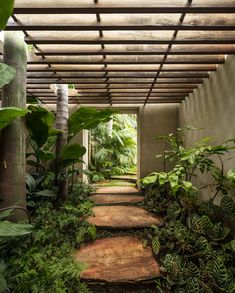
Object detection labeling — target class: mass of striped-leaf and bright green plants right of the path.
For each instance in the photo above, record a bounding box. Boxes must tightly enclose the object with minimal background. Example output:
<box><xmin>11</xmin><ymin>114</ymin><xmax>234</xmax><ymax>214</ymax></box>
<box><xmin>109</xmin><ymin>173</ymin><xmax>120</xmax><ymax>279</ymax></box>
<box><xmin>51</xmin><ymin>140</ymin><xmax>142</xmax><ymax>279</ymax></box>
<box><xmin>141</xmin><ymin>129</ymin><xmax>235</xmax><ymax>293</ymax></box>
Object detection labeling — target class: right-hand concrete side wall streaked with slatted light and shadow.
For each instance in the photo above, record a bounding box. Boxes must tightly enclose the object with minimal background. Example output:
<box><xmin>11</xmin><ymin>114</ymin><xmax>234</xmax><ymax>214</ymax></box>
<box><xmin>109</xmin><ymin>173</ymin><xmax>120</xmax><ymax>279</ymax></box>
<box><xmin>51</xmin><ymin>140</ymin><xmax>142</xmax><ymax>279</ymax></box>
<box><xmin>179</xmin><ymin>56</ymin><xmax>235</xmax><ymax>201</ymax></box>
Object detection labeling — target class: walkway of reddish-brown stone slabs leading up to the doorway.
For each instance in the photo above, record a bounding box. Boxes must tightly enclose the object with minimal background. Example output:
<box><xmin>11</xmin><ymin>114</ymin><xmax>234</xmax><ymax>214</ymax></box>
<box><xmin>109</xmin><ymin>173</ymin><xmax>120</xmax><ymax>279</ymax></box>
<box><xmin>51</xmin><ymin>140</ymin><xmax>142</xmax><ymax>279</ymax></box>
<box><xmin>77</xmin><ymin>186</ymin><xmax>163</xmax><ymax>284</ymax></box>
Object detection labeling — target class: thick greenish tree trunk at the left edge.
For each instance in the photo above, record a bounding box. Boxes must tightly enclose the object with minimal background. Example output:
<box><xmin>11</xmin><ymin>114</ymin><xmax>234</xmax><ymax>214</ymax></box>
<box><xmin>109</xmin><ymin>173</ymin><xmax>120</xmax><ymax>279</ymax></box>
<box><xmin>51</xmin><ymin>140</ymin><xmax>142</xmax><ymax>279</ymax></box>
<box><xmin>0</xmin><ymin>32</ymin><xmax>27</xmax><ymax>220</ymax></box>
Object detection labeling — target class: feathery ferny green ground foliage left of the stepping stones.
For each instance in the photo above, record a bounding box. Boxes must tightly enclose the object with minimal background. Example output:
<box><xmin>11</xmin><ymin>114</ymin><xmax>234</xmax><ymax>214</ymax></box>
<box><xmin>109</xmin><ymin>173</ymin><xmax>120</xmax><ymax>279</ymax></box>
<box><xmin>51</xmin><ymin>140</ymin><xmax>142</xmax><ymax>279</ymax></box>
<box><xmin>0</xmin><ymin>183</ymin><xmax>96</xmax><ymax>293</ymax></box>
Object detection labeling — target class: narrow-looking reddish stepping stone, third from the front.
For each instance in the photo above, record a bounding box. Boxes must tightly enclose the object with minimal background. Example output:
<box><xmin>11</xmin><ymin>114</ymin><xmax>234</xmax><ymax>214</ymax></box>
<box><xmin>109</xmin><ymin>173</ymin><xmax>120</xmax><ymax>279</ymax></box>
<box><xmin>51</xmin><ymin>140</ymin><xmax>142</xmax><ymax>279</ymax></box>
<box><xmin>90</xmin><ymin>194</ymin><xmax>144</xmax><ymax>204</ymax></box>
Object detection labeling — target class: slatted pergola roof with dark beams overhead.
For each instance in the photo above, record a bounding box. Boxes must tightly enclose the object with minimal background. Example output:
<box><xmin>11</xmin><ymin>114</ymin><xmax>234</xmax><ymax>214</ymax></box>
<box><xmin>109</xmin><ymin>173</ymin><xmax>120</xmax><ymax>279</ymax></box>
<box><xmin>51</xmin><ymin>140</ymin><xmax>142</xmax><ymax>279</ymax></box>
<box><xmin>2</xmin><ymin>0</ymin><xmax>235</xmax><ymax>104</ymax></box>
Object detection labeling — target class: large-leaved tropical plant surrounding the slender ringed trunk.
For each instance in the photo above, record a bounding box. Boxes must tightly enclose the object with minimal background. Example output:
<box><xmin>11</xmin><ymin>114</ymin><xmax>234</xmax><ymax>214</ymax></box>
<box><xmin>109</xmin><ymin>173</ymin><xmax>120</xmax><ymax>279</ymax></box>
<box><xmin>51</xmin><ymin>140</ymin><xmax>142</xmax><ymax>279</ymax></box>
<box><xmin>25</xmin><ymin>105</ymin><xmax>113</xmax><ymax>203</ymax></box>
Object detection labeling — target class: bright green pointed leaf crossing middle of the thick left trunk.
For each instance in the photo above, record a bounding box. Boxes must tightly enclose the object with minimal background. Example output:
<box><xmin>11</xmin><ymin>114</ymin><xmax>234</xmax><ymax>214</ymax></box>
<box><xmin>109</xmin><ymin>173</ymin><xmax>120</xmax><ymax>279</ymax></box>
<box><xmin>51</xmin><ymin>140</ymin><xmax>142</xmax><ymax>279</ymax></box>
<box><xmin>0</xmin><ymin>107</ymin><xmax>29</xmax><ymax>129</ymax></box>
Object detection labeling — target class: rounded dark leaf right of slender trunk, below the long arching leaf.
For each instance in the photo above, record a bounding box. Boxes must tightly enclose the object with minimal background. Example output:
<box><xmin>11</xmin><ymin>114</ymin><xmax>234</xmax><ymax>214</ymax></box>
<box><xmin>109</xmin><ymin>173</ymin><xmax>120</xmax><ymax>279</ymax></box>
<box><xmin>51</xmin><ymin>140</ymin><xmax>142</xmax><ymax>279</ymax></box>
<box><xmin>61</xmin><ymin>143</ymin><xmax>86</xmax><ymax>166</ymax></box>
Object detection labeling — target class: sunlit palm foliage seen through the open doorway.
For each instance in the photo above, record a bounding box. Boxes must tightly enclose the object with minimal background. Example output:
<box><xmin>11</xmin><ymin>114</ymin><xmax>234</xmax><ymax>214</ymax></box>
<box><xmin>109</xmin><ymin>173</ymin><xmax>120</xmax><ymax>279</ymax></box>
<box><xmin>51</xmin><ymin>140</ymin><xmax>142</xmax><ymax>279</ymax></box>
<box><xmin>87</xmin><ymin>114</ymin><xmax>137</xmax><ymax>182</ymax></box>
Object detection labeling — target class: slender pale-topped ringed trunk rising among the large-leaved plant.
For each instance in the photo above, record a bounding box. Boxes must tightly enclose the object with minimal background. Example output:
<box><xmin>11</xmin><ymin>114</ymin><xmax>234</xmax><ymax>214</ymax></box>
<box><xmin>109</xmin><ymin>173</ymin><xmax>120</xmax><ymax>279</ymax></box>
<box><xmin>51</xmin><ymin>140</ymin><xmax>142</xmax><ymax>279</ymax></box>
<box><xmin>56</xmin><ymin>84</ymin><xmax>69</xmax><ymax>201</ymax></box>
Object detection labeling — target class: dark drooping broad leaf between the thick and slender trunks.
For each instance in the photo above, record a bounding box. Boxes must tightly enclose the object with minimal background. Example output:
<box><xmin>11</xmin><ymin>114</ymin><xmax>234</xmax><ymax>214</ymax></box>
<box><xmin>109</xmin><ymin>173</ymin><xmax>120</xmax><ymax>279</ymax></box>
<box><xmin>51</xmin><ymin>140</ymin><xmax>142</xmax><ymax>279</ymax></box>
<box><xmin>25</xmin><ymin>105</ymin><xmax>55</xmax><ymax>147</ymax></box>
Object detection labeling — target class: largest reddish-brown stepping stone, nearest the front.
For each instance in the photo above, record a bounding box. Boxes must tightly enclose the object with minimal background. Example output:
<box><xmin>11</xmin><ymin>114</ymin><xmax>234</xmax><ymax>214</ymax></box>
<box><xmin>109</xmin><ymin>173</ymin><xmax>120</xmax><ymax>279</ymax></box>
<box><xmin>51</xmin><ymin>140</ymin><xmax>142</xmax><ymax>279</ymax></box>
<box><xmin>76</xmin><ymin>236</ymin><xmax>160</xmax><ymax>283</ymax></box>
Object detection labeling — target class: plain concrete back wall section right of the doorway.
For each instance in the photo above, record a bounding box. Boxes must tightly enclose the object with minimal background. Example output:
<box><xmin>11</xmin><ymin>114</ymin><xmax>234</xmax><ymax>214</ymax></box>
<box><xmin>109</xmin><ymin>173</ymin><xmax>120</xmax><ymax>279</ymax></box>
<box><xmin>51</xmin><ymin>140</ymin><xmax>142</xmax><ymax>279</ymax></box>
<box><xmin>139</xmin><ymin>104</ymin><xmax>179</xmax><ymax>178</ymax></box>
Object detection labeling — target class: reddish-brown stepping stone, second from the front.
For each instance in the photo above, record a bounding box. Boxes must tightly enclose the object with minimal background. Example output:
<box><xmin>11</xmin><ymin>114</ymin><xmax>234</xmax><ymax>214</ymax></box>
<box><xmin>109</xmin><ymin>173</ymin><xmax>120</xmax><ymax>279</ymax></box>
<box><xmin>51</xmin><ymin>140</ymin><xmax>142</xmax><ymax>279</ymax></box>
<box><xmin>87</xmin><ymin>206</ymin><xmax>164</xmax><ymax>229</ymax></box>
